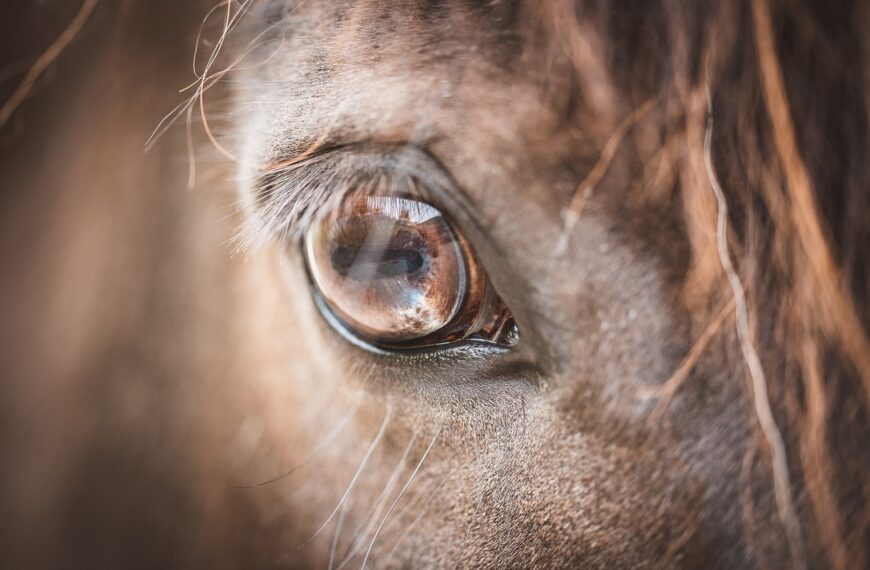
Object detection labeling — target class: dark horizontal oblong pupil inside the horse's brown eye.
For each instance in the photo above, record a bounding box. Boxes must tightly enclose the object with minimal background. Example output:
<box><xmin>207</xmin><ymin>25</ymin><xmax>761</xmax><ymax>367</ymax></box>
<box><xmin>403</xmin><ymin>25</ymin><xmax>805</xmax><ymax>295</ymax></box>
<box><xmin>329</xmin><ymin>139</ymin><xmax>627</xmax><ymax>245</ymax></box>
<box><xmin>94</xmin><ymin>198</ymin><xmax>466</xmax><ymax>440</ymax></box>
<box><xmin>331</xmin><ymin>246</ymin><xmax>425</xmax><ymax>281</ymax></box>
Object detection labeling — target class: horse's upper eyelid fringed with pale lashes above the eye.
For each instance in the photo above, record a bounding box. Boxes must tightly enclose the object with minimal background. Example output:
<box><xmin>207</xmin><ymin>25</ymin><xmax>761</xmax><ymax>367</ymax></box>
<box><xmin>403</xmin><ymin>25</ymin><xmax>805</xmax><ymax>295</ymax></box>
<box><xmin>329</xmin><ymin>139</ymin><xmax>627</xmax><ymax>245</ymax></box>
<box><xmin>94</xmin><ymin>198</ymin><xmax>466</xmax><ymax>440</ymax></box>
<box><xmin>237</xmin><ymin>144</ymin><xmax>479</xmax><ymax>249</ymax></box>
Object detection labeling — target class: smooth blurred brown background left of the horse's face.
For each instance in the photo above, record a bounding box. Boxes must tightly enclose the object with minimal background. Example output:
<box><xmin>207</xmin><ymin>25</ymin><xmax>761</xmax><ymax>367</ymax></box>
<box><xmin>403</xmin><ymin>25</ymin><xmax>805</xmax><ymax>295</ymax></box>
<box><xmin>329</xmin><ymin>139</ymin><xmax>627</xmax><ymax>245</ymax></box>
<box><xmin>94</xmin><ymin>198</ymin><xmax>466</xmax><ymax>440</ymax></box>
<box><xmin>0</xmin><ymin>0</ymin><xmax>262</xmax><ymax>568</ymax></box>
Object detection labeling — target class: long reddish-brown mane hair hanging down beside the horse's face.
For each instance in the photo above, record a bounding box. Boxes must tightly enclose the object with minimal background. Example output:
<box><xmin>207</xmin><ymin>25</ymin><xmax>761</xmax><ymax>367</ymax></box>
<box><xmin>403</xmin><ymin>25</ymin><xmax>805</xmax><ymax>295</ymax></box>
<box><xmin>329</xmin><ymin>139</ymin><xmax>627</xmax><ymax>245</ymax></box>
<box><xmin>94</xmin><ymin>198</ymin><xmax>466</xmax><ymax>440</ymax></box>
<box><xmin>538</xmin><ymin>0</ymin><xmax>870</xmax><ymax>568</ymax></box>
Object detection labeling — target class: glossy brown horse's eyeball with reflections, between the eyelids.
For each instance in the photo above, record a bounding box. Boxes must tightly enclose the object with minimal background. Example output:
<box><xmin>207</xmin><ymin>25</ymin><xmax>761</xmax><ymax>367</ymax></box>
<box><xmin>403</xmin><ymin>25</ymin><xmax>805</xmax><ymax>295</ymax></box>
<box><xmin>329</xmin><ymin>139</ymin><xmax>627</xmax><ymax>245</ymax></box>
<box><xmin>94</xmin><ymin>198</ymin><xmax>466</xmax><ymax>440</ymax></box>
<box><xmin>305</xmin><ymin>196</ymin><xmax>516</xmax><ymax>349</ymax></box>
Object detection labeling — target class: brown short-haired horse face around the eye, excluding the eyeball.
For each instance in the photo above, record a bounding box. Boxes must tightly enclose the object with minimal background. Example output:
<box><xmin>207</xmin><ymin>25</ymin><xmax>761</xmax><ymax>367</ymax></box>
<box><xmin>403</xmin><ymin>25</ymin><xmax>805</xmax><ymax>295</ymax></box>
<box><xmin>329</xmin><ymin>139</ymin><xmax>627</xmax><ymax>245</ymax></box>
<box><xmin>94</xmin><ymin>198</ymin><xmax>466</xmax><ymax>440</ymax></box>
<box><xmin>221</xmin><ymin>2</ymin><xmax>746</xmax><ymax>568</ymax></box>
